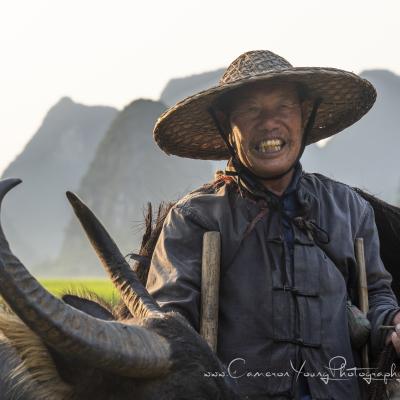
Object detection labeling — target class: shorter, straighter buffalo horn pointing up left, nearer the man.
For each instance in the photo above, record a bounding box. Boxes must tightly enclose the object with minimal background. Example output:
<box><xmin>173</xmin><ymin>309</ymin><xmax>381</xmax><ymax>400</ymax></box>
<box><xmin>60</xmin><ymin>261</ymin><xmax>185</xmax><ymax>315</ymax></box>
<box><xmin>66</xmin><ymin>192</ymin><xmax>161</xmax><ymax>317</ymax></box>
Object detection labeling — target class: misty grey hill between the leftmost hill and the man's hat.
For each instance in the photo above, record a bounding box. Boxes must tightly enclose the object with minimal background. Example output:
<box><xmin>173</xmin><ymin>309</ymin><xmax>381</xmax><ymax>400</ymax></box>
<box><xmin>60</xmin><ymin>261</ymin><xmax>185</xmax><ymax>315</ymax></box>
<box><xmin>50</xmin><ymin>99</ymin><xmax>213</xmax><ymax>276</ymax></box>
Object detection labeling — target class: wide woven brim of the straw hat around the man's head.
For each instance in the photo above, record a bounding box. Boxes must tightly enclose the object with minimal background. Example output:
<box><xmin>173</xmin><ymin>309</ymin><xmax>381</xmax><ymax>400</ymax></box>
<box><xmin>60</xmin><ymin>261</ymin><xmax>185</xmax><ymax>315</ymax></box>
<box><xmin>153</xmin><ymin>67</ymin><xmax>376</xmax><ymax>160</ymax></box>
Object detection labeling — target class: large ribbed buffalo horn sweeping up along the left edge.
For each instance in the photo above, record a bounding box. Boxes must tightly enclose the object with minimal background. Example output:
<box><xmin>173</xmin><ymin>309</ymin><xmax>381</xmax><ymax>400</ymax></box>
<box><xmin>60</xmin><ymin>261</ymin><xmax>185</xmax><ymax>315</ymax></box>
<box><xmin>0</xmin><ymin>179</ymin><xmax>171</xmax><ymax>377</ymax></box>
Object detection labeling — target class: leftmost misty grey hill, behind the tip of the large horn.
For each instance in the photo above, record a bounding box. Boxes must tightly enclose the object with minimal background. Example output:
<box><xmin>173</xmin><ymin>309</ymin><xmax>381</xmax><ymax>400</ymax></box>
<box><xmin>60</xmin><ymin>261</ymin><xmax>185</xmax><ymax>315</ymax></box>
<box><xmin>2</xmin><ymin>97</ymin><xmax>117</xmax><ymax>264</ymax></box>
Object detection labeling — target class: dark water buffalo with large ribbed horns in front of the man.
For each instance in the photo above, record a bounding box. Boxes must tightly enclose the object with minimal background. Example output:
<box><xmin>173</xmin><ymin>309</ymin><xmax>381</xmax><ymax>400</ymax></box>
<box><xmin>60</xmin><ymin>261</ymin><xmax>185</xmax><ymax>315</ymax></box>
<box><xmin>0</xmin><ymin>179</ymin><xmax>400</xmax><ymax>400</ymax></box>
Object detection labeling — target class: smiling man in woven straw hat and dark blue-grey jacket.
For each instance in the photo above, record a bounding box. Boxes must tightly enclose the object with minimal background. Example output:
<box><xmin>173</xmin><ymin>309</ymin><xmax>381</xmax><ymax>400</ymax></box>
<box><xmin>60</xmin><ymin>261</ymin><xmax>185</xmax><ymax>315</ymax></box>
<box><xmin>147</xmin><ymin>51</ymin><xmax>400</xmax><ymax>400</ymax></box>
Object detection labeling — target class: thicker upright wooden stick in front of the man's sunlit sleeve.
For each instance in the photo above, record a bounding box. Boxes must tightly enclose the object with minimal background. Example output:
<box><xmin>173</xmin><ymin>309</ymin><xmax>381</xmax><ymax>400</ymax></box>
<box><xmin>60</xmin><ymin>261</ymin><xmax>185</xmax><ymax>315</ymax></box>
<box><xmin>200</xmin><ymin>232</ymin><xmax>221</xmax><ymax>352</ymax></box>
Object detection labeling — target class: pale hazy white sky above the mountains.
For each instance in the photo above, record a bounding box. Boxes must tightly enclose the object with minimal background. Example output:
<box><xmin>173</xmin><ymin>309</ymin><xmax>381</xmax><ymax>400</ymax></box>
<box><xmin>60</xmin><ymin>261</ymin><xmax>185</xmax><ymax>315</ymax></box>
<box><xmin>0</xmin><ymin>0</ymin><xmax>400</xmax><ymax>174</ymax></box>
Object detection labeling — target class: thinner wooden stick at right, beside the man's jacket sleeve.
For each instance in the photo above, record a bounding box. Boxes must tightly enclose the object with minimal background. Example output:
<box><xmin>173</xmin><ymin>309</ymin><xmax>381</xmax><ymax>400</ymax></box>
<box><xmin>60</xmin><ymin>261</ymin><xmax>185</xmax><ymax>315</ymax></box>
<box><xmin>355</xmin><ymin>238</ymin><xmax>369</xmax><ymax>368</ymax></box>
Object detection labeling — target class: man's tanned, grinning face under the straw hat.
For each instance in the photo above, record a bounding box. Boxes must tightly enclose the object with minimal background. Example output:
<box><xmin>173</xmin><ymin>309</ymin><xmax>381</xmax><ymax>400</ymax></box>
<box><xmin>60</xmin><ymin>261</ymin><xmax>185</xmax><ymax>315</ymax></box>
<box><xmin>225</xmin><ymin>83</ymin><xmax>304</xmax><ymax>177</ymax></box>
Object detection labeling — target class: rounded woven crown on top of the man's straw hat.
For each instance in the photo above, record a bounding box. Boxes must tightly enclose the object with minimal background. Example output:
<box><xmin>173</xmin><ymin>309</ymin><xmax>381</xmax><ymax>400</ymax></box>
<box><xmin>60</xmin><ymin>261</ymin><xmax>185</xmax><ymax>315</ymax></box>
<box><xmin>219</xmin><ymin>50</ymin><xmax>293</xmax><ymax>85</ymax></box>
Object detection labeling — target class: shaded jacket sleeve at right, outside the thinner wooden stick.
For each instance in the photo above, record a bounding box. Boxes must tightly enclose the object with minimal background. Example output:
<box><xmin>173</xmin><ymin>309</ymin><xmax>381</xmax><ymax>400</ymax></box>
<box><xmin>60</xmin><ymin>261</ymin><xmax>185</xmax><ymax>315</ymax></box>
<box><xmin>356</xmin><ymin>203</ymin><xmax>400</xmax><ymax>356</ymax></box>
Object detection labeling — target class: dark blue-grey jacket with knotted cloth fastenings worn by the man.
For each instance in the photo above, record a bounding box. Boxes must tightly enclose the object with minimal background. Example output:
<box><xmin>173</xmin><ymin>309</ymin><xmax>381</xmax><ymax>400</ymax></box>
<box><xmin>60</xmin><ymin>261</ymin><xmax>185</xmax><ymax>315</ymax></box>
<box><xmin>147</xmin><ymin>169</ymin><xmax>399</xmax><ymax>400</ymax></box>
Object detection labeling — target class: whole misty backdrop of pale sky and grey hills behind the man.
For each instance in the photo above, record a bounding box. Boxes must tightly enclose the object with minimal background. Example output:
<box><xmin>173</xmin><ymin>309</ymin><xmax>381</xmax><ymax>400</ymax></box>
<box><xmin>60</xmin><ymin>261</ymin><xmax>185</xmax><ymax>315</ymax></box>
<box><xmin>0</xmin><ymin>0</ymin><xmax>400</xmax><ymax>277</ymax></box>
